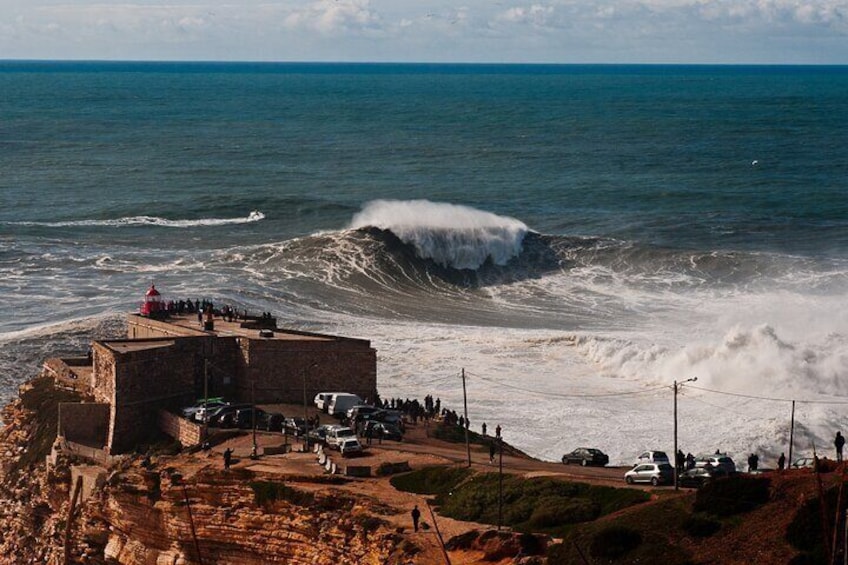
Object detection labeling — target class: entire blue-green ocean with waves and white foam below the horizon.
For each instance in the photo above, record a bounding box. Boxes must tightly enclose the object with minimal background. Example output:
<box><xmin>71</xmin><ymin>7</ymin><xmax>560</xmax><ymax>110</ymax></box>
<box><xmin>0</xmin><ymin>61</ymin><xmax>848</xmax><ymax>467</ymax></box>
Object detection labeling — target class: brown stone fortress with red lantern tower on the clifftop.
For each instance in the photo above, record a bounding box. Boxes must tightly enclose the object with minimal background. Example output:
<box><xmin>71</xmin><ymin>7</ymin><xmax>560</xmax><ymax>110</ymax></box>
<box><xmin>44</xmin><ymin>287</ymin><xmax>377</xmax><ymax>459</ymax></box>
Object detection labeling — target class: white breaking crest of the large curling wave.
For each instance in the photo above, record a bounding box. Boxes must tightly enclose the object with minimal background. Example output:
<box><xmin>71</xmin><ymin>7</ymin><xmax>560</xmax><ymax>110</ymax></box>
<box><xmin>350</xmin><ymin>200</ymin><xmax>528</xmax><ymax>269</ymax></box>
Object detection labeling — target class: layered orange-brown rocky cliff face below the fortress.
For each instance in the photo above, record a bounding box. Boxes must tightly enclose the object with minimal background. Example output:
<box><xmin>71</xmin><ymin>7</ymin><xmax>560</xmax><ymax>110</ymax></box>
<box><xmin>0</xmin><ymin>376</ymin><xmax>409</xmax><ymax>565</ymax></box>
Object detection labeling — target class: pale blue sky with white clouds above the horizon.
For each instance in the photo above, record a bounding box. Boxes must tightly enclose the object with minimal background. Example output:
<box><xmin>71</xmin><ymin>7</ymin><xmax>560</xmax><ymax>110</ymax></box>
<box><xmin>0</xmin><ymin>0</ymin><xmax>848</xmax><ymax>64</ymax></box>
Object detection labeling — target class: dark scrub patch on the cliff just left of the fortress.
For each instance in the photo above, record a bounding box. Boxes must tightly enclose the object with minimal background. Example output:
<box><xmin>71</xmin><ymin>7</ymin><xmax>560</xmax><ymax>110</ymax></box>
<box><xmin>10</xmin><ymin>377</ymin><xmax>81</xmax><ymax>476</ymax></box>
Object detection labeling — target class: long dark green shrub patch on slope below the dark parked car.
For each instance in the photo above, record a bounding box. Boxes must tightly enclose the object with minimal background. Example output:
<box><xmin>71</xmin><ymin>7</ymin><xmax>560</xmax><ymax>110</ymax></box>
<box><xmin>392</xmin><ymin>467</ymin><xmax>648</xmax><ymax>534</ymax></box>
